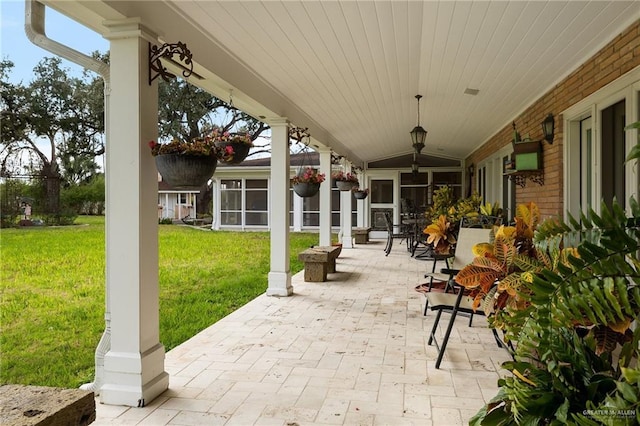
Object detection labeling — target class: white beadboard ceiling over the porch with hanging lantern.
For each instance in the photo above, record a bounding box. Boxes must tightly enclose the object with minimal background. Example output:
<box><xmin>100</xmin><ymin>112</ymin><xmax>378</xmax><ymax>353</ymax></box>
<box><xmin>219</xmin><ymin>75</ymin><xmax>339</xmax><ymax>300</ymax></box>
<box><xmin>44</xmin><ymin>0</ymin><xmax>640</xmax><ymax>164</ymax></box>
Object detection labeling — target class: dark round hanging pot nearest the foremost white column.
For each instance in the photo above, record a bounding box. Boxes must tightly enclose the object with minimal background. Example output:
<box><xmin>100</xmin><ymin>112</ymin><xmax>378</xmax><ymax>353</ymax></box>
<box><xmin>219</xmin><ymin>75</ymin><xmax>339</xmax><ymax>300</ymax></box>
<box><xmin>156</xmin><ymin>154</ymin><xmax>218</xmax><ymax>188</ymax></box>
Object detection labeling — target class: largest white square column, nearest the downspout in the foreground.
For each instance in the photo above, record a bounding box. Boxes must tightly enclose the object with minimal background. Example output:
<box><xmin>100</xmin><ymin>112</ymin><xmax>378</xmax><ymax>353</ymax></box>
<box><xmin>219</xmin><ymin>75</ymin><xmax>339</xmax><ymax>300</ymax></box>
<box><xmin>100</xmin><ymin>20</ymin><xmax>169</xmax><ymax>407</ymax></box>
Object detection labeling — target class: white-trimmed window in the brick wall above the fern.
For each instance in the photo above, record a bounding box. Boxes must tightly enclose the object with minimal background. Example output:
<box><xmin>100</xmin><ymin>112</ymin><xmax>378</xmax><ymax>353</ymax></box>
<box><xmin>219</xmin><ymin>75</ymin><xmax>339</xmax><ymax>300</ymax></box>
<box><xmin>563</xmin><ymin>70</ymin><xmax>640</xmax><ymax>217</ymax></box>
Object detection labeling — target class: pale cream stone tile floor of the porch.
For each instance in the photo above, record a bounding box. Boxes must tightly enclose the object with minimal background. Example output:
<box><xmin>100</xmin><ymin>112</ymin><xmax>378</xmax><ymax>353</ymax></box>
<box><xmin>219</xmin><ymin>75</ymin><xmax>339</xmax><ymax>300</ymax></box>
<box><xmin>93</xmin><ymin>240</ymin><xmax>509</xmax><ymax>426</ymax></box>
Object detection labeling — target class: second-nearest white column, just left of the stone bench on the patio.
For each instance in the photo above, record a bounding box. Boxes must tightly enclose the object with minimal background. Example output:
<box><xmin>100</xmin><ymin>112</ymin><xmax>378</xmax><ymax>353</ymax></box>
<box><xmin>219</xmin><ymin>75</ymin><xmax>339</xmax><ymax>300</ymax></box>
<box><xmin>267</xmin><ymin>118</ymin><xmax>293</xmax><ymax>296</ymax></box>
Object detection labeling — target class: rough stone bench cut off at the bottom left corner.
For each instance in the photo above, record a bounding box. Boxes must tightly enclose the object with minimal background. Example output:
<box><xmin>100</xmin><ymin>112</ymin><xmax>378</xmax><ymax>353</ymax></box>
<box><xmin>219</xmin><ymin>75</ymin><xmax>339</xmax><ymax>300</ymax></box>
<box><xmin>0</xmin><ymin>385</ymin><xmax>96</xmax><ymax>426</ymax></box>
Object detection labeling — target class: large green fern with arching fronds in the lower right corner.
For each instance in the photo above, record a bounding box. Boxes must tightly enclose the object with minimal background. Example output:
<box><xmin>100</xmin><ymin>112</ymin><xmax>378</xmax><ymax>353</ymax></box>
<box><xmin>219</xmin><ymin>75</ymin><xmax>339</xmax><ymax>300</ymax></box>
<box><xmin>470</xmin><ymin>191</ymin><xmax>640</xmax><ymax>426</ymax></box>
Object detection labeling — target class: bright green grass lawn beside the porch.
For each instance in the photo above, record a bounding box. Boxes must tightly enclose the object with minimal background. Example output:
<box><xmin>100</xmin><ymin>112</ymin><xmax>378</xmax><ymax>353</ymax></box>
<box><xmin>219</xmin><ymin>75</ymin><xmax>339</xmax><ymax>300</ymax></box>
<box><xmin>0</xmin><ymin>216</ymin><xmax>318</xmax><ymax>388</ymax></box>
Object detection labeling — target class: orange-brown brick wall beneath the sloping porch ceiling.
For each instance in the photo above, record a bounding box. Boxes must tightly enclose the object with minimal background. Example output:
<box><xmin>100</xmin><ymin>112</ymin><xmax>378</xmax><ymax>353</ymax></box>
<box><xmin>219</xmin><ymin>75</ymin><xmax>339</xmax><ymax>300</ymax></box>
<box><xmin>466</xmin><ymin>20</ymin><xmax>640</xmax><ymax>217</ymax></box>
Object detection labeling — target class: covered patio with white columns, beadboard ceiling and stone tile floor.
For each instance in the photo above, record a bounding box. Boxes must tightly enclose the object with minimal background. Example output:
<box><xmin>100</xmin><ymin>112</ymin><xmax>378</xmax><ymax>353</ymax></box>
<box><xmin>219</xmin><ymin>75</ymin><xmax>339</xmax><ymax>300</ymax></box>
<box><xmin>26</xmin><ymin>0</ymin><xmax>640</xmax><ymax>425</ymax></box>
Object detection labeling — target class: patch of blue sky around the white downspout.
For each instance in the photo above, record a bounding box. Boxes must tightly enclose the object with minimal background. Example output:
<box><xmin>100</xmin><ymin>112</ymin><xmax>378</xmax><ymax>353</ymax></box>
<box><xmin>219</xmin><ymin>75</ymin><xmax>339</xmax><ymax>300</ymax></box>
<box><xmin>0</xmin><ymin>0</ymin><xmax>109</xmax><ymax>85</ymax></box>
